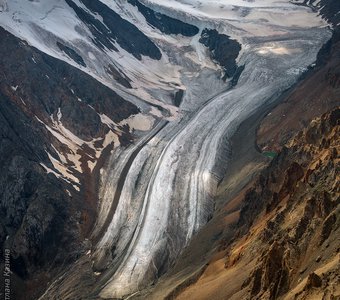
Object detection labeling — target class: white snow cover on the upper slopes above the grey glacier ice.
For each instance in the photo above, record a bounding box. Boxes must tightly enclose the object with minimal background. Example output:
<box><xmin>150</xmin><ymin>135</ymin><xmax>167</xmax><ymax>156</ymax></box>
<box><xmin>0</xmin><ymin>0</ymin><xmax>325</xmax><ymax>120</ymax></box>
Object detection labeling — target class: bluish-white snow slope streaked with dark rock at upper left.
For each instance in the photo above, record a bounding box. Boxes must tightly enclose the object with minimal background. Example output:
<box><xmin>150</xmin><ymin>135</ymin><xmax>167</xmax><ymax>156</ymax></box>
<box><xmin>0</xmin><ymin>0</ymin><xmax>191</xmax><ymax>116</ymax></box>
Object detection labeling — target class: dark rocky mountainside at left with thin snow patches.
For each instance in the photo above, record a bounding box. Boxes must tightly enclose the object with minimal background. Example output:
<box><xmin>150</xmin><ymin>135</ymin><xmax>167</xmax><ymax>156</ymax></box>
<box><xmin>0</xmin><ymin>28</ymin><xmax>139</xmax><ymax>299</ymax></box>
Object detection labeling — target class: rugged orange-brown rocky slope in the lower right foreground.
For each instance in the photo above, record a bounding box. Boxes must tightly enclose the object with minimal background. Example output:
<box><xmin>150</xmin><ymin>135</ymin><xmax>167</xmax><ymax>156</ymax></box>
<box><xmin>171</xmin><ymin>108</ymin><xmax>340</xmax><ymax>299</ymax></box>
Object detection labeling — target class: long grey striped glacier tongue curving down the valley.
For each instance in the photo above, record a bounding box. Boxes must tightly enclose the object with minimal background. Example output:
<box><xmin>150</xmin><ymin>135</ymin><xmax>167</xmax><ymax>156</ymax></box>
<box><xmin>95</xmin><ymin>29</ymin><xmax>327</xmax><ymax>298</ymax></box>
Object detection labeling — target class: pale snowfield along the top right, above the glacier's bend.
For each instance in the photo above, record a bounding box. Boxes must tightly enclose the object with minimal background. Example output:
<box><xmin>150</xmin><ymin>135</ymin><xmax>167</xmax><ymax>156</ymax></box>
<box><xmin>141</xmin><ymin>0</ymin><xmax>326</xmax><ymax>38</ymax></box>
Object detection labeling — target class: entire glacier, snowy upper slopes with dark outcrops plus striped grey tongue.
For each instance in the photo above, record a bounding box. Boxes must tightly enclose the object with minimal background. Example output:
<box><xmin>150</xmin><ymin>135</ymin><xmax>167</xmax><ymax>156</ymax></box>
<box><xmin>0</xmin><ymin>0</ymin><xmax>330</xmax><ymax>299</ymax></box>
